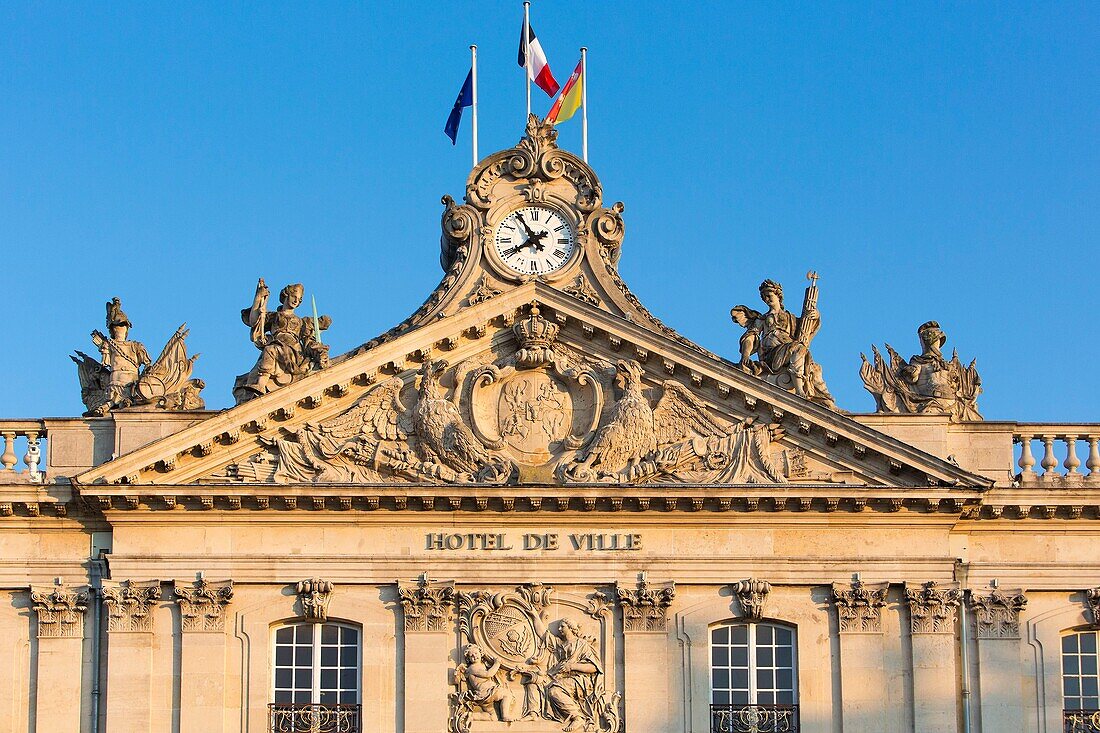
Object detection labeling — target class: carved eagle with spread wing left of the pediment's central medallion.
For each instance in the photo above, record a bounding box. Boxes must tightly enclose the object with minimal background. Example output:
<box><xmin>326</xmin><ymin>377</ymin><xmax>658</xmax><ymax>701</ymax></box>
<box><xmin>255</xmin><ymin>361</ymin><xmax>512</xmax><ymax>483</ymax></box>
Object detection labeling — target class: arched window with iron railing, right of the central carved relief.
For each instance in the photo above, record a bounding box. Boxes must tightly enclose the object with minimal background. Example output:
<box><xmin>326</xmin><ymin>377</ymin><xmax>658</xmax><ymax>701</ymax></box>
<box><xmin>711</xmin><ymin>623</ymin><xmax>799</xmax><ymax>733</ymax></box>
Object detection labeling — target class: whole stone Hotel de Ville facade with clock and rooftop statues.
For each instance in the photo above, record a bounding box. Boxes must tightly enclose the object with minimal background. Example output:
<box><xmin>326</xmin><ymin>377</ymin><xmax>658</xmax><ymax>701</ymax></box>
<box><xmin>0</xmin><ymin>118</ymin><xmax>1100</xmax><ymax>733</ymax></box>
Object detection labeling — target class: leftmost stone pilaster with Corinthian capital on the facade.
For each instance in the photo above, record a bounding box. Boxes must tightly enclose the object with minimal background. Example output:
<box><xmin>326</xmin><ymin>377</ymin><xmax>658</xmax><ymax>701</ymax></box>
<box><xmin>31</xmin><ymin>582</ymin><xmax>88</xmax><ymax>731</ymax></box>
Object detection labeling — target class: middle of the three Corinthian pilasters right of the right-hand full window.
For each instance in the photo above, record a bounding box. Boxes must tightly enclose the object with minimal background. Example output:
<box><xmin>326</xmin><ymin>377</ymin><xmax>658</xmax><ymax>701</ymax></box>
<box><xmin>905</xmin><ymin>581</ymin><xmax>960</xmax><ymax>733</ymax></box>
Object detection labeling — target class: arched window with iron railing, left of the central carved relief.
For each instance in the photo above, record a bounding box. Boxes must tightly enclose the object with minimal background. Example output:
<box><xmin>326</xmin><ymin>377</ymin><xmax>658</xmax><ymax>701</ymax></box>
<box><xmin>271</xmin><ymin>622</ymin><xmax>361</xmax><ymax>733</ymax></box>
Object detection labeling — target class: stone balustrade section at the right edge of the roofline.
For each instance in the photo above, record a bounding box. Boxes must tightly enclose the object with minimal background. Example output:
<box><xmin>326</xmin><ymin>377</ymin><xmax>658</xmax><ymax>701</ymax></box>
<box><xmin>1012</xmin><ymin>423</ymin><xmax>1100</xmax><ymax>486</ymax></box>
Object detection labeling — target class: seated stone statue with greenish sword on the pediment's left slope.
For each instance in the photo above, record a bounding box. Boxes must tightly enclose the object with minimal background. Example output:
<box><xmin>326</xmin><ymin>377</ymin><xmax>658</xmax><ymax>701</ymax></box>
<box><xmin>233</xmin><ymin>277</ymin><xmax>332</xmax><ymax>404</ymax></box>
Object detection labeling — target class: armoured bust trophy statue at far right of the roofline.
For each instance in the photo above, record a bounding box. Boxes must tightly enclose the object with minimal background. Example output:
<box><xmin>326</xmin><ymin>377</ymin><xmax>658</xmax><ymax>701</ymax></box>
<box><xmin>859</xmin><ymin>320</ymin><xmax>982</xmax><ymax>422</ymax></box>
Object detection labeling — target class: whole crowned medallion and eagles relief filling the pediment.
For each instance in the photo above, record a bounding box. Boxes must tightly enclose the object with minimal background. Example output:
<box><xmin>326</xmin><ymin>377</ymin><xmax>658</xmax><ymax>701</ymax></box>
<box><xmin>227</xmin><ymin>304</ymin><xmax>810</xmax><ymax>484</ymax></box>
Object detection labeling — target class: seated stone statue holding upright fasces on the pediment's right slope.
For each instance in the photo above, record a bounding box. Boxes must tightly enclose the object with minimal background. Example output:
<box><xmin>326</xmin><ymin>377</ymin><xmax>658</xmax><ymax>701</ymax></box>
<box><xmin>729</xmin><ymin>272</ymin><xmax>837</xmax><ymax>409</ymax></box>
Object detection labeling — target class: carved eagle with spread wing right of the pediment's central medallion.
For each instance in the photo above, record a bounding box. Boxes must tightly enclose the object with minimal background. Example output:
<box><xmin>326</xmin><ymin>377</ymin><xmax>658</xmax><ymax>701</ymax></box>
<box><xmin>561</xmin><ymin>361</ymin><xmax>787</xmax><ymax>483</ymax></box>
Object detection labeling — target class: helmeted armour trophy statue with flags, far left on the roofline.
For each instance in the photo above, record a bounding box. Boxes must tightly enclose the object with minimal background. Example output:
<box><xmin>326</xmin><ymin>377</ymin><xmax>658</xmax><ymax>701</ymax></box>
<box><xmin>70</xmin><ymin>298</ymin><xmax>206</xmax><ymax>416</ymax></box>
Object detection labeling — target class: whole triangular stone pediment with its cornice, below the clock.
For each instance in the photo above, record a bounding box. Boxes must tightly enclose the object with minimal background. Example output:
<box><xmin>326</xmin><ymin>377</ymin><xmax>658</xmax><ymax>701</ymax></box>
<box><xmin>75</xmin><ymin>282</ymin><xmax>991</xmax><ymax>495</ymax></box>
